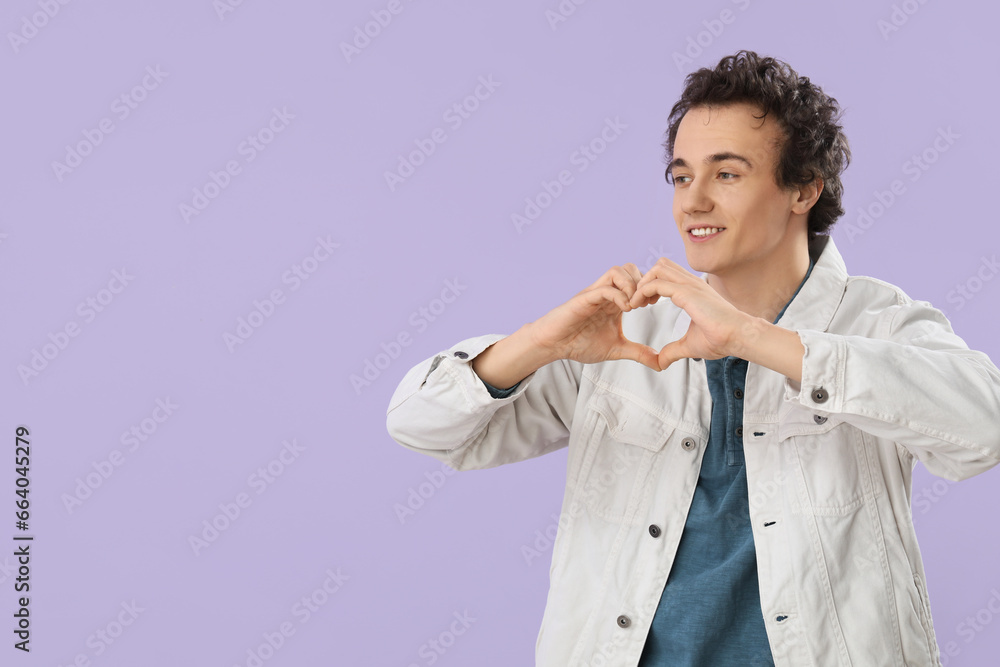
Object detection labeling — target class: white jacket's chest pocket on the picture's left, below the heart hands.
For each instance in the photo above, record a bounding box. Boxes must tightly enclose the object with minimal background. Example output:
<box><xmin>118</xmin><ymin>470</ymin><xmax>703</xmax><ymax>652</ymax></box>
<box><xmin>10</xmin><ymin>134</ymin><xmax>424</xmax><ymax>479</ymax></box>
<box><xmin>574</xmin><ymin>389</ymin><xmax>674</xmax><ymax>523</ymax></box>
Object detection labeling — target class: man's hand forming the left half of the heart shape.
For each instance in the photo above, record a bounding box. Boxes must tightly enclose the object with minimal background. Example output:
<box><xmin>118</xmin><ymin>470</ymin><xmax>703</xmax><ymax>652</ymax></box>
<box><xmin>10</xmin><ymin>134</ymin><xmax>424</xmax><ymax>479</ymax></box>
<box><xmin>531</xmin><ymin>262</ymin><xmax>662</xmax><ymax>371</ymax></box>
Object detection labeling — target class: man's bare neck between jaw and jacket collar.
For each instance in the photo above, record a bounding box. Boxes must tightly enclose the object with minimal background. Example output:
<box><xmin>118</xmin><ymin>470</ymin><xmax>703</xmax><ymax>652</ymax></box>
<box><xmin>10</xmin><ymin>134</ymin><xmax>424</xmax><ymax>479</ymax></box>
<box><xmin>707</xmin><ymin>236</ymin><xmax>809</xmax><ymax>322</ymax></box>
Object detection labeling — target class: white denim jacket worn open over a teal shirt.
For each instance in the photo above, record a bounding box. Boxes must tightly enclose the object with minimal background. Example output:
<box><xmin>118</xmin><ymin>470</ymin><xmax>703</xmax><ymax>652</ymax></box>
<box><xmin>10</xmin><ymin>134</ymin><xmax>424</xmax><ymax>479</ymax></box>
<box><xmin>387</xmin><ymin>237</ymin><xmax>1000</xmax><ymax>667</ymax></box>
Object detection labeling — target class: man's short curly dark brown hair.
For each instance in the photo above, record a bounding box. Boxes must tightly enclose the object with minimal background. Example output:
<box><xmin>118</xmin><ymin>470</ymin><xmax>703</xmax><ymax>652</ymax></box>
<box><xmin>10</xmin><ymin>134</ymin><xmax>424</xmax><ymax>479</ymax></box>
<box><xmin>663</xmin><ymin>50</ymin><xmax>851</xmax><ymax>240</ymax></box>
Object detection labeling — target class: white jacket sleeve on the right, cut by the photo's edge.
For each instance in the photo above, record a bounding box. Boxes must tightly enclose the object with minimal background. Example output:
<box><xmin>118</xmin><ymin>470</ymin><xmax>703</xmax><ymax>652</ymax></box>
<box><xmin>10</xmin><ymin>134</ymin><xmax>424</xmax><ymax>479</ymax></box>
<box><xmin>785</xmin><ymin>301</ymin><xmax>1000</xmax><ymax>481</ymax></box>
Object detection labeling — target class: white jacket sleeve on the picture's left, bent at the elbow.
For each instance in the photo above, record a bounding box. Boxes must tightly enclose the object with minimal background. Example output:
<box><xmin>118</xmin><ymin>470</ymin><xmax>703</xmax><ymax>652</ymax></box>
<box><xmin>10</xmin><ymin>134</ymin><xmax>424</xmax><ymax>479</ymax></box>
<box><xmin>386</xmin><ymin>334</ymin><xmax>583</xmax><ymax>470</ymax></box>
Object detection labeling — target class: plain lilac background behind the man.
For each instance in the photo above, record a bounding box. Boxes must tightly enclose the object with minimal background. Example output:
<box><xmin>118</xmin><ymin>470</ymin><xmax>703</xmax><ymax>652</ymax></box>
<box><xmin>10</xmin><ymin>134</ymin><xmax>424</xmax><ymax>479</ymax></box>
<box><xmin>0</xmin><ymin>0</ymin><xmax>1000</xmax><ymax>667</ymax></box>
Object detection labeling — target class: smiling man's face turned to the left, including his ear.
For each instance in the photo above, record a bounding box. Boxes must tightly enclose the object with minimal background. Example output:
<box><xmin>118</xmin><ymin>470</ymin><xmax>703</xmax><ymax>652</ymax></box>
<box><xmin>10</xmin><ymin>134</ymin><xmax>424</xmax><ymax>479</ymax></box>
<box><xmin>669</xmin><ymin>103</ymin><xmax>807</xmax><ymax>277</ymax></box>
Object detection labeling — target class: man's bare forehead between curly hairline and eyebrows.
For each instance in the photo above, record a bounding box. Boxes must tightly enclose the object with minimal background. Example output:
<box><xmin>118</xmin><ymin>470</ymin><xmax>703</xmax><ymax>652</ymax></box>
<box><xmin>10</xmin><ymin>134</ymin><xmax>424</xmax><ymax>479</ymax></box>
<box><xmin>674</xmin><ymin>103</ymin><xmax>781</xmax><ymax>164</ymax></box>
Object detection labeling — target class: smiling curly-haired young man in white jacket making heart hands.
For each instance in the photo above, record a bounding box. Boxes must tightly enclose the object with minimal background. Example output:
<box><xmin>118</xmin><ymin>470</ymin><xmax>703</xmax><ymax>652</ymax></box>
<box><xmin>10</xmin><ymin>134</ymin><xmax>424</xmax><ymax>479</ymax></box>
<box><xmin>387</xmin><ymin>51</ymin><xmax>1000</xmax><ymax>667</ymax></box>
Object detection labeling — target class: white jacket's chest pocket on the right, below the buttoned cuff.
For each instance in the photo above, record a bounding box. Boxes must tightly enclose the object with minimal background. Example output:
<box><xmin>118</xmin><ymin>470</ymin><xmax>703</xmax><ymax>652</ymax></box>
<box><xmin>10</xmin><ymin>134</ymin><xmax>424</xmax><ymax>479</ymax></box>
<box><xmin>778</xmin><ymin>403</ymin><xmax>864</xmax><ymax>515</ymax></box>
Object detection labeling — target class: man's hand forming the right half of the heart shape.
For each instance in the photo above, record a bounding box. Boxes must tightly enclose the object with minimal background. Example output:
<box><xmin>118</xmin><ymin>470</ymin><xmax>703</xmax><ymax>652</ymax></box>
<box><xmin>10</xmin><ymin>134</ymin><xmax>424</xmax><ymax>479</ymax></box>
<box><xmin>629</xmin><ymin>257</ymin><xmax>749</xmax><ymax>370</ymax></box>
